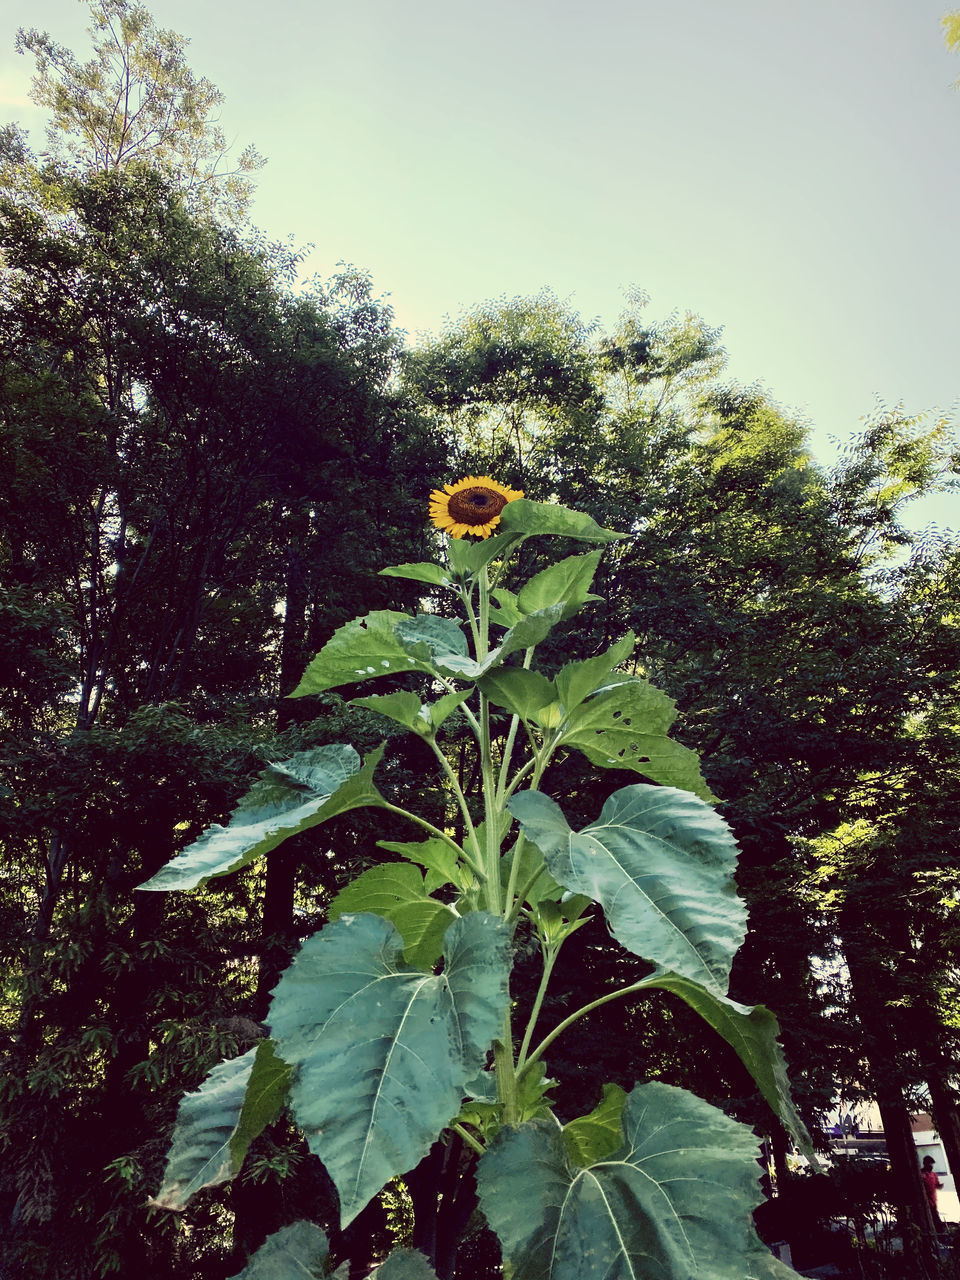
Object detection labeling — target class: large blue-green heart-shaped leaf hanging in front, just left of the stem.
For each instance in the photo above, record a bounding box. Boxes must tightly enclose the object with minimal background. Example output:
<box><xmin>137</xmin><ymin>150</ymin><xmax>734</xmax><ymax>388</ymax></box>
<box><xmin>270</xmin><ymin>911</ymin><xmax>509</xmax><ymax>1226</ymax></box>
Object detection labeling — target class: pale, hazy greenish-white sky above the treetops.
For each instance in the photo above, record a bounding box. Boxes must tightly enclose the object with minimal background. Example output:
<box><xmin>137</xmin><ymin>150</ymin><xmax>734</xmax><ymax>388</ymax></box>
<box><xmin>0</xmin><ymin>0</ymin><xmax>960</xmax><ymax>525</ymax></box>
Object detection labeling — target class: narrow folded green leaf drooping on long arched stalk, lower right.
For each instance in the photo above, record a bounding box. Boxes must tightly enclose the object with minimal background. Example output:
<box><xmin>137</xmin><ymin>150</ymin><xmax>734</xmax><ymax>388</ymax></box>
<box><xmin>643</xmin><ymin>969</ymin><xmax>812</xmax><ymax>1151</ymax></box>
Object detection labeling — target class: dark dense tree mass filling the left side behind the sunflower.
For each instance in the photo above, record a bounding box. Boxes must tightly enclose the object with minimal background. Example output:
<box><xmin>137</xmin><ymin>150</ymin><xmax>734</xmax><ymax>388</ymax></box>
<box><xmin>0</xmin><ymin>169</ymin><xmax>442</xmax><ymax>1277</ymax></box>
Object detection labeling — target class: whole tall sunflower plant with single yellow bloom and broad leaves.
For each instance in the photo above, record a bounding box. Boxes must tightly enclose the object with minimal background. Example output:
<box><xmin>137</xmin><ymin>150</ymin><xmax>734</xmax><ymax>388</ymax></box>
<box><xmin>141</xmin><ymin>476</ymin><xmax>806</xmax><ymax>1280</ymax></box>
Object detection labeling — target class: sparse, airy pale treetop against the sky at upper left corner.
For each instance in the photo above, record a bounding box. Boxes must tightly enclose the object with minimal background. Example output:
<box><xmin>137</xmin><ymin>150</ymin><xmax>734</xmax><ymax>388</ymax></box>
<box><xmin>8</xmin><ymin>0</ymin><xmax>265</xmax><ymax>221</ymax></box>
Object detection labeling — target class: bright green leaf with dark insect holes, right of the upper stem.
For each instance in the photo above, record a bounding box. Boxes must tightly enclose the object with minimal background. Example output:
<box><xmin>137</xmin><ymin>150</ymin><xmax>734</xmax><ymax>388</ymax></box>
<box><xmin>561</xmin><ymin>680</ymin><xmax>714</xmax><ymax>800</ymax></box>
